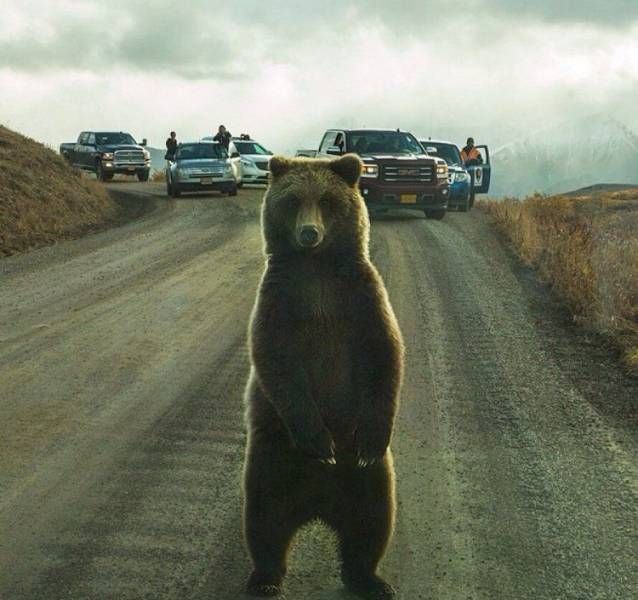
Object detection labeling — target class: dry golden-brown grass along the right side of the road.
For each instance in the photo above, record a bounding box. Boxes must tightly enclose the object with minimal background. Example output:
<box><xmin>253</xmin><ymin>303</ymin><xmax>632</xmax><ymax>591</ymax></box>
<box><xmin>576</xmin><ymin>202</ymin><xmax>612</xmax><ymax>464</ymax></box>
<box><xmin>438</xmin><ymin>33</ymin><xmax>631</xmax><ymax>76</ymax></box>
<box><xmin>481</xmin><ymin>190</ymin><xmax>638</xmax><ymax>372</ymax></box>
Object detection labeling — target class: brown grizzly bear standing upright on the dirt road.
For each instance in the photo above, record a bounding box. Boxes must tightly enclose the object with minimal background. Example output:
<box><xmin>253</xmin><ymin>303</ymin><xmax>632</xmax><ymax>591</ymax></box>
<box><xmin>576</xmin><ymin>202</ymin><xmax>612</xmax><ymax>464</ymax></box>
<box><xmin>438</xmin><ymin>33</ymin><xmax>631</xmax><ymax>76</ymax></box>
<box><xmin>244</xmin><ymin>155</ymin><xmax>403</xmax><ymax>598</ymax></box>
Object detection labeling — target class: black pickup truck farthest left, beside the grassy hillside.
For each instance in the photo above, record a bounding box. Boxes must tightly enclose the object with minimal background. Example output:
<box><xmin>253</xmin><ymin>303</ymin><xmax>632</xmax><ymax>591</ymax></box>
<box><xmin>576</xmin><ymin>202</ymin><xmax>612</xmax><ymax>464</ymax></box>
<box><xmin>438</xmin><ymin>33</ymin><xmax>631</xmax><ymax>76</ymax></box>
<box><xmin>60</xmin><ymin>131</ymin><xmax>151</xmax><ymax>181</ymax></box>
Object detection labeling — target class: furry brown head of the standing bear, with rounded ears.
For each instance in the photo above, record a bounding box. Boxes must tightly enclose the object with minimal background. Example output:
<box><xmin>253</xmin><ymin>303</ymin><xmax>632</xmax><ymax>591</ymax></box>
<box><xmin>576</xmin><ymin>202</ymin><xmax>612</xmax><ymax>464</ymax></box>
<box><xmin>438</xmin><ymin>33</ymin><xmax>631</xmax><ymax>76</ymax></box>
<box><xmin>262</xmin><ymin>154</ymin><xmax>369</xmax><ymax>256</ymax></box>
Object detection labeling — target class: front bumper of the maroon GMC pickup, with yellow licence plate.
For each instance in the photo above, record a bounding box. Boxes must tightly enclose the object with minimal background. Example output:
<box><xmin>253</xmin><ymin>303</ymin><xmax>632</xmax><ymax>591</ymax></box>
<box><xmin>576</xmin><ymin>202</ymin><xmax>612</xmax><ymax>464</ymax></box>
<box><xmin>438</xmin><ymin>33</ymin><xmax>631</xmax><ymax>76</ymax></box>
<box><xmin>359</xmin><ymin>180</ymin><xmax>449</xmax><ymax>210</ymax></box>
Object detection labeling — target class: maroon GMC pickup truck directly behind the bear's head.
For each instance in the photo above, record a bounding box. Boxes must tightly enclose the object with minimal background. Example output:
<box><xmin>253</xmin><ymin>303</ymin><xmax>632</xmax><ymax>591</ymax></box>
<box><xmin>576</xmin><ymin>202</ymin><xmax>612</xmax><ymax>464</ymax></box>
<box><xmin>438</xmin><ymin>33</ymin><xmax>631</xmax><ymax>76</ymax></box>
<box><xmin>316</xmin><ymin>129</ymin><xmax>449</xmax><ymax>219</ymax></box>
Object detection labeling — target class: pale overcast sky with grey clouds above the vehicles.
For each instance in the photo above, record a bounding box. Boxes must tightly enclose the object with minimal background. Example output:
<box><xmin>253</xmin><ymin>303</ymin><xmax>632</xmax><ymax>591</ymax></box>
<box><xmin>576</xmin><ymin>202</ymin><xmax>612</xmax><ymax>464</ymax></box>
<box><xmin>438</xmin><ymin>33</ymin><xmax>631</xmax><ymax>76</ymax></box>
<box><xmin>0</xmin><ymin>0</ymin><xmax>638</xmax><ymax>151</ymax></box>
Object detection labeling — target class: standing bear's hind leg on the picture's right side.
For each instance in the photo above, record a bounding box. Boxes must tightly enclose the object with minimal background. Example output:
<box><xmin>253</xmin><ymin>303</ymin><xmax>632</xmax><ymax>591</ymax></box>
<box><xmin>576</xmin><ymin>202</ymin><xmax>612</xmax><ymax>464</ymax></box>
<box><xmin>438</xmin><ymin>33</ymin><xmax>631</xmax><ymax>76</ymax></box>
<box><xmin>333</xmin><ymin>452</ymin><xmax>395</xmax><ymax>600</ymax></box>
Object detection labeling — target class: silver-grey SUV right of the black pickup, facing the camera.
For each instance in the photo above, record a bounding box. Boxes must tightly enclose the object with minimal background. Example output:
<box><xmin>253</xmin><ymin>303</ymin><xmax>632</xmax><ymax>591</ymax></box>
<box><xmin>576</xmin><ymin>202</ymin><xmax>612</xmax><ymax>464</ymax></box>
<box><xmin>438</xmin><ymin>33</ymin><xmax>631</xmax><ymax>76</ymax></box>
<box><xmin>166</xmin><ymin>142</ymin><xmax>237</xmax><ymax>197</ymax></box>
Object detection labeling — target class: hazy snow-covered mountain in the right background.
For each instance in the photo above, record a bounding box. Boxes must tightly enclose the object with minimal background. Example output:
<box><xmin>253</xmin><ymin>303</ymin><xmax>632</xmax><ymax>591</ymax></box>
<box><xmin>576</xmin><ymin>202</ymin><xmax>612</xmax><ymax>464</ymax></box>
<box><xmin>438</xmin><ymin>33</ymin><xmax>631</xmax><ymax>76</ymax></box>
<box><xmin>490</xmin><ymin>115</ymin><xmax>638</xmax><ymax>196</ymax></box>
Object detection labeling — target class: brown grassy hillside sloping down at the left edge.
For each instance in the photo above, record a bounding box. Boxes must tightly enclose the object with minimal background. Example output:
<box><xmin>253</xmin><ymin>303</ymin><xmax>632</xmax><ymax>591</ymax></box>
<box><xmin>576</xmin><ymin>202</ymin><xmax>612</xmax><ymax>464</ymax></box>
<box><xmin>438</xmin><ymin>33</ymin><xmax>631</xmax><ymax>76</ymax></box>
<box><xmin>0</xmin><ymin>125</ymin><xmax>119</xmax><ymax>256</ymax></box>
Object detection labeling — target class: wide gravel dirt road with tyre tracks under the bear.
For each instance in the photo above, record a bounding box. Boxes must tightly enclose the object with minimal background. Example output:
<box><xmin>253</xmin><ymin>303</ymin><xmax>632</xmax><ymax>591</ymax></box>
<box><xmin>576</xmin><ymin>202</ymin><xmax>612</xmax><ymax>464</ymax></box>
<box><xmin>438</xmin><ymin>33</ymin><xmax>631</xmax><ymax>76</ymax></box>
<box><xmin>0</xmin><ymin>184</ymin><xmax>638</xmax><ymax>600</ymax></box>
